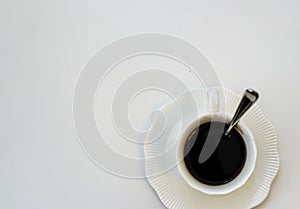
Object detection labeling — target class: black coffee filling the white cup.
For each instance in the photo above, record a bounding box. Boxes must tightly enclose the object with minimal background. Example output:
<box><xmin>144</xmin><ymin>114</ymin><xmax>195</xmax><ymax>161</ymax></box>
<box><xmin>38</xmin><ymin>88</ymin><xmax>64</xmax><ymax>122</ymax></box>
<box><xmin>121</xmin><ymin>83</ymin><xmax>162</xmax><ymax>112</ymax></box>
<box><xmin>184</xmin><ymin>122</ymin><xmax>247</xmax><ymax>185</ymax></box>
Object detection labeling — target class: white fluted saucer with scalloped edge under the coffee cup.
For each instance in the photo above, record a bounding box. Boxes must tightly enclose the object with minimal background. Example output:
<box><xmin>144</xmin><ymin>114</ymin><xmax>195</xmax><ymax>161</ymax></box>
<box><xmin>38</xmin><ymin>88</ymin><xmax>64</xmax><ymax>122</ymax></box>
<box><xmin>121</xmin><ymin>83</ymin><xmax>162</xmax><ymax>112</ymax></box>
<box><xmin>144</xmin><ymin>89</ymin><xmax>279</xmax><ymax>209</ymax></box>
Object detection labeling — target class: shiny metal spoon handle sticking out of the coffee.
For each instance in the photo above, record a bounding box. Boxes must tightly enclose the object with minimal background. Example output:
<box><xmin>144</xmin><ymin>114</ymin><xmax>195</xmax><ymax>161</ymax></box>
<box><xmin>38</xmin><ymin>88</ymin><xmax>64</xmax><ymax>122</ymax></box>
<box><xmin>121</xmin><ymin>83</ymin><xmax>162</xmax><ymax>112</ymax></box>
<box><xmin>225</xmin><ymin>89</ymin><xmax>259</xmax><ymax>136</ymax></box>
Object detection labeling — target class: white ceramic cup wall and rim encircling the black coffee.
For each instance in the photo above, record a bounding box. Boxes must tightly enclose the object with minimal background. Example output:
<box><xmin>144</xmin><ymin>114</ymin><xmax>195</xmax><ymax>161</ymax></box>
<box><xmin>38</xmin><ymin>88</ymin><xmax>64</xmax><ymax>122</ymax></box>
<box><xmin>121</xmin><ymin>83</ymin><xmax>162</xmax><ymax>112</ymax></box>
<box><xmin>176</xmin><ymin>113</ymin><xmax>257</xmax><ymax>195</ymax></box>
